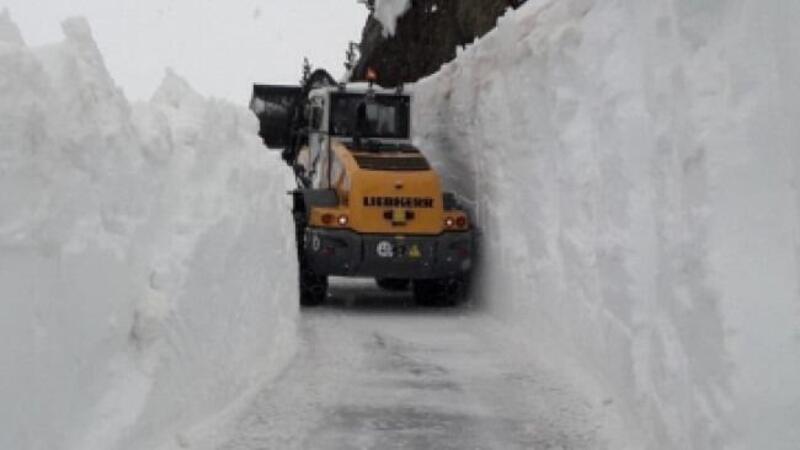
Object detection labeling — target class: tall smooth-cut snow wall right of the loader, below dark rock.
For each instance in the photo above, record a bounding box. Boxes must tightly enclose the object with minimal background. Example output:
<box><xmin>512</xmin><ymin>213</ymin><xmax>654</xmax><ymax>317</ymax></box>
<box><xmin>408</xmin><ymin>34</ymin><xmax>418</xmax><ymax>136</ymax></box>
<box><xmin>414</xmin><ymin>0</ymin><xmax>800</xmax><ymax>450</ymax></box>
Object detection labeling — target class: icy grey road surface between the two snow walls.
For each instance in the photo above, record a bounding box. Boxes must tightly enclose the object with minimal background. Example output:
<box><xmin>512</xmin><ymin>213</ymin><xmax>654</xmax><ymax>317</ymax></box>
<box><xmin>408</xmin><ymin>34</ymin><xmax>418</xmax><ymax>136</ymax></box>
<box><xmin>218</xmin><ymin>281</ymin><xmax>607</xmax><ymax>450</ymax></box>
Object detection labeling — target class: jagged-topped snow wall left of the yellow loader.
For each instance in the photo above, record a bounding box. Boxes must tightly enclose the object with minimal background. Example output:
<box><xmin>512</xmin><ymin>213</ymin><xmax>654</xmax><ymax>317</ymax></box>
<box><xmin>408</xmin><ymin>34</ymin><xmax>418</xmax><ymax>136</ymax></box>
<box><xmin>0</xmin><ymin>13</ymin><xmax>297</xmax><ymax>450</ymax></box>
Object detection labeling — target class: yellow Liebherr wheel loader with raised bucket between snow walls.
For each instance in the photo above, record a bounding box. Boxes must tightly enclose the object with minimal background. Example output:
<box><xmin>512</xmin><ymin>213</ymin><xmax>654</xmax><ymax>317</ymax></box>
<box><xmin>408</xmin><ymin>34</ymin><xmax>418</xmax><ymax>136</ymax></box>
<box><xmin>250</xmin><ymin>70</ymin><xmax>474</xmax><ymax>306</ymax></box>
